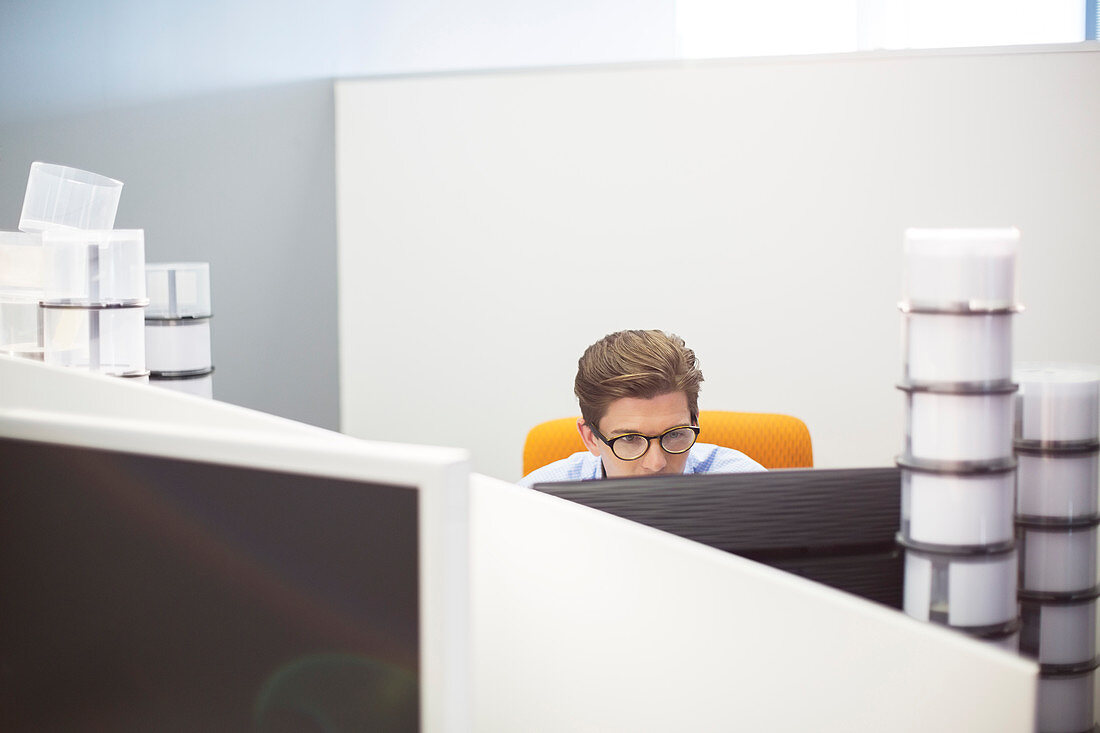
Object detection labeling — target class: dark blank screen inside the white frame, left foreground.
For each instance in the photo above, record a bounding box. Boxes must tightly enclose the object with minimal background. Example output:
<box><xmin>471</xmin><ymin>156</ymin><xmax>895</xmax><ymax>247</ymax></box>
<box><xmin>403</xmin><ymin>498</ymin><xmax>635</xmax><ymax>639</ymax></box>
<box><xmin>0</xmin><ymin>439</ymin><xmax>420</xmax><ymax>731</ymax></box>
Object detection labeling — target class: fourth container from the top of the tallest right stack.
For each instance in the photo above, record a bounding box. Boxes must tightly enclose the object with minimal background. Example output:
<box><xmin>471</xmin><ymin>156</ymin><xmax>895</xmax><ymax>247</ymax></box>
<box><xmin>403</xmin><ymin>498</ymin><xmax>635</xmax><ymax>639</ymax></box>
<box><xmin>901</xmin><ymin>468</ymin><xmax>1015</xmax><ymax>546</ymax></box>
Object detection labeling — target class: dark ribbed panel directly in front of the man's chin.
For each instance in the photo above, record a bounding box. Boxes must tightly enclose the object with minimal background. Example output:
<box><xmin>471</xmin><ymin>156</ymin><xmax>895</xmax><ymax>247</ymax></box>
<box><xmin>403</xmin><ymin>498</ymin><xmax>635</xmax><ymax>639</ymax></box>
<box><xmin>535</xmin><ymin>468</ymin><xmax>903</xmax><ymax>609</ymax></box>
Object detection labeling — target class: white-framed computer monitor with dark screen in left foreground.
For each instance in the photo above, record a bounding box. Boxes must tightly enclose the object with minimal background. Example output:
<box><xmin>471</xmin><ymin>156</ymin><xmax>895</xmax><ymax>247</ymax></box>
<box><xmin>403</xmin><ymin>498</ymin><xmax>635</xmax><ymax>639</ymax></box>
<box><xmin>0</xmin><ymin>363</ymin><xmax>470</xmax><ymax>732</ymax></box>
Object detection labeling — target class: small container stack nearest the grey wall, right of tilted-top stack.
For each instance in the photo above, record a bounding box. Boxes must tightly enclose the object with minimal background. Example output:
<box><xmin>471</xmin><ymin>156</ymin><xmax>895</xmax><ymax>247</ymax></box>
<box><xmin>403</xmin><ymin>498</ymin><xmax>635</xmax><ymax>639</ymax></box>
<box><xmin>145</xmin><ymin>262</ymin><xmax>213</xmax><ymax>397</ymax></box>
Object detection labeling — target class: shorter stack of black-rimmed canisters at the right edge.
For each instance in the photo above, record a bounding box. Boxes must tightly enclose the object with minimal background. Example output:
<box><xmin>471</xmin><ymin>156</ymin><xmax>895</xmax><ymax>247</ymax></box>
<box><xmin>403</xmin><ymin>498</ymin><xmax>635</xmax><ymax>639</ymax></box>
<box><xmin>1015</xmin><ymin>364</ymin><xmax>1100</xmax><ymax>733</ymax></box>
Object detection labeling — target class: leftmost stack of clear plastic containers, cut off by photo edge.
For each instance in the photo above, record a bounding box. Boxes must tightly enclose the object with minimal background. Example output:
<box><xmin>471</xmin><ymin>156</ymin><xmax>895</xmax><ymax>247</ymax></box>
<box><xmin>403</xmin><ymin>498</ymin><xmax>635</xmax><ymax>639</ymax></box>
<box><xmin>0</xmin><ymin>231</ymin><xmax>43</xmax><ymax>360</ymax></box>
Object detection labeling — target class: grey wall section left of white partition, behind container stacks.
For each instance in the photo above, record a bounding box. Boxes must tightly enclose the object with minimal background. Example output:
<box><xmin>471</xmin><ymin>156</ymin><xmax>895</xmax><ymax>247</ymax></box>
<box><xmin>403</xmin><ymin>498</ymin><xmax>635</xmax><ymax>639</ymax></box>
<box><xmin>0</xmin><ymin>81</ymin><xmax>338</xmax><ymax>427</ymax></box>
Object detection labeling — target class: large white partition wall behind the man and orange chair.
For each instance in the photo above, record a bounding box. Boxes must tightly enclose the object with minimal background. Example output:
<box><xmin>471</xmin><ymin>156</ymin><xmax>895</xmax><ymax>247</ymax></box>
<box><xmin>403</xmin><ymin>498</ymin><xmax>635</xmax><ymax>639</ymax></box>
<box><xmin>337</xmin><ymin>43</ymin><xmax>1100</xmax><ymax>480</ymax></box>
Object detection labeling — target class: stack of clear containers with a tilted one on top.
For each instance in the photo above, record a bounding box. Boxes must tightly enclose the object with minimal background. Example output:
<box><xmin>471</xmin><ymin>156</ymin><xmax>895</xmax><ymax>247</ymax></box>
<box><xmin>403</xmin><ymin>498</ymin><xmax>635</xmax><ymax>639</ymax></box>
<box><xmin>19</xmin><ymin>163</ymin><xmax>149</xmax><ymax>380</ymax></box>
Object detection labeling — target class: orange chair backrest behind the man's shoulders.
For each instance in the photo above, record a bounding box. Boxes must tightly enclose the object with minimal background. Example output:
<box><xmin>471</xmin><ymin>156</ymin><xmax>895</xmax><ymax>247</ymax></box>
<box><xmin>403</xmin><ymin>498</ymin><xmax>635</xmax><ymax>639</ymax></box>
<box><xmin>524</xmin><ymin>409</ymin><xmax>814</xmax><ymax>475</ymax></box>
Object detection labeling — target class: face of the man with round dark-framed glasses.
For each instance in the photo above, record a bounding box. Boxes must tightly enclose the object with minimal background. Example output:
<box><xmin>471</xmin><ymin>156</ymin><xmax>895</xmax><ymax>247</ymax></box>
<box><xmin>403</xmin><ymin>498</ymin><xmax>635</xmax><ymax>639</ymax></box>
<box><xmin>578</xmin><ymin>392</ymin><xmax>691</xmax><ymax>478</ymax></box>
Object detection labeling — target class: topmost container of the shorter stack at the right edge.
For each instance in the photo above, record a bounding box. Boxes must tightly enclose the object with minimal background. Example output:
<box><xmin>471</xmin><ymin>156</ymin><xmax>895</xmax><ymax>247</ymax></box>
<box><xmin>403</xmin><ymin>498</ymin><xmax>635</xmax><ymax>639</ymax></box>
<box><xmin>1014</xmin><ymin>364</ymin><xmax>1100</xmax><ymax>444</ymax></box>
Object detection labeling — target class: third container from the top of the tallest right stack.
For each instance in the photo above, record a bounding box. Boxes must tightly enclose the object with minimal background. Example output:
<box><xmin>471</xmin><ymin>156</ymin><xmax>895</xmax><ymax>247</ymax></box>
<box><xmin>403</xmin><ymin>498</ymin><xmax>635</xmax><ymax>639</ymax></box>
<box><xmin>903</xmin><ymin>385</ymin><xmax>1015</xmax><ymax>461</ymax></box>
